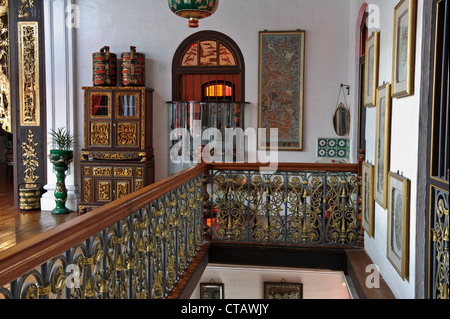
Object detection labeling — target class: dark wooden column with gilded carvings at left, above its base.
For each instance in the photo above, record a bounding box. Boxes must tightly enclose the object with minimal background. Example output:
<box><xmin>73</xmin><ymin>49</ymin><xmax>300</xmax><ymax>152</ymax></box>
<box><xmin>9</xmin><ymin>0</ymin><xmax>47</xmax><ymax>207</ymax></box>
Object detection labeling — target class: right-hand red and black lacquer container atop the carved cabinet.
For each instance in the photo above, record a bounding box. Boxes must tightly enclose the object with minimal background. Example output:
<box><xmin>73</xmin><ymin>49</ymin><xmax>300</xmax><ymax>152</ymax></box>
<box><xmin>121</xmin><ymin>46</ymin><xmax>145</xmax><ymax>86</ymax></box>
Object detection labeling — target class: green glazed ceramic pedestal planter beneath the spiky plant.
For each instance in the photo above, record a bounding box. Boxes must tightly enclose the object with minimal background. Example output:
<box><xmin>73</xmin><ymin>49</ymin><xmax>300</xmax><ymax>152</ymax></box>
<box><xmin>49</xmin><ymin>150</ymin><xmax>73</xmax><ymax>215</ymax></box>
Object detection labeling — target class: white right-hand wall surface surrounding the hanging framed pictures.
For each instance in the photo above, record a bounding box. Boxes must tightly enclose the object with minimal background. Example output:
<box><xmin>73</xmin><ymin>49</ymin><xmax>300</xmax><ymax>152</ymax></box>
<box><xmin>350</xmin><ymin>0</ymin><xmax>423</xmax><ymax>298</ymax></box>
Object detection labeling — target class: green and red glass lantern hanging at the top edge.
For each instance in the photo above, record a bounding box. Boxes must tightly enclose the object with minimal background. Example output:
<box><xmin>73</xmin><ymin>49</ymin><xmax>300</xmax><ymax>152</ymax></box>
<box><xmin>168</xmin><ymin>0</ymin><xmax>219</xmax><ymax>28</ymax></box>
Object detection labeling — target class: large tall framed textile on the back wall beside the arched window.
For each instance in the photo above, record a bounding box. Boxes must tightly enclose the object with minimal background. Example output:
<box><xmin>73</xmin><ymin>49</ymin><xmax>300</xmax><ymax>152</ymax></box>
<box><xmin>258</xmin><ymin>30</ymin><xmax>305</xmax><ymax>151</ymax></box>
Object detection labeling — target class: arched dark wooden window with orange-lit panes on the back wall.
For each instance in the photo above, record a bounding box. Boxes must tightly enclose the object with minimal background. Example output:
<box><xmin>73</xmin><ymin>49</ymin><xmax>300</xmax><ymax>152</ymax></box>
<box><xmin>172</xmin><ymin>31</ymin><xmax>245</xmax><ymax>102</ymax></box>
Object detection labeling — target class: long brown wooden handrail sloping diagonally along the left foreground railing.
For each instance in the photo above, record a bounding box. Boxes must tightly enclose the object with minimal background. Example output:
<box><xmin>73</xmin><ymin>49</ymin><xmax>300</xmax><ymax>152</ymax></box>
<box><xmin>0</xmin><ymin>164</ymin><xmax>208</xmax><ymax>286</ymax></box>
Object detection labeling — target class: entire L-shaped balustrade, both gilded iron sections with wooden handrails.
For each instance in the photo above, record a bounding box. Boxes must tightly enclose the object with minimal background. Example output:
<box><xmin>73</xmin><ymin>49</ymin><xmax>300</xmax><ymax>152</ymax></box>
<box><xmin>0</xmin><ymin>163</ymin><xmax>361</xmax><ymax>299</ymax></box>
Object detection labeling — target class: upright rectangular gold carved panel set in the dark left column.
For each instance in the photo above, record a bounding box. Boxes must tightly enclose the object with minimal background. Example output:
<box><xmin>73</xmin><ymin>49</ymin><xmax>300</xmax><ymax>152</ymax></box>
<box><xmin>18</xmin><ymin>21</ymin><xmax>41</xmax><ymax>126</ymax></box>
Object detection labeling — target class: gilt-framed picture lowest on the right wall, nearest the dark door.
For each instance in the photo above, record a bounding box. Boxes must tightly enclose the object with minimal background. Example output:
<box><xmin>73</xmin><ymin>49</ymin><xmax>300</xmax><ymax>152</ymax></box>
<box><xmin>387</xmin><ymin>172</ymin><xmax>410</xmax><ymax>280</ymax></box>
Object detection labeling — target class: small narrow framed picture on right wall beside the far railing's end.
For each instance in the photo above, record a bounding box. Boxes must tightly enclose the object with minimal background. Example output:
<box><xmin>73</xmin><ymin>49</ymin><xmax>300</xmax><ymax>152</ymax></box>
<box><xmin>362</xmin><ymin>162</ymin><xmax>375</xmax><ymax>237</ymax></box>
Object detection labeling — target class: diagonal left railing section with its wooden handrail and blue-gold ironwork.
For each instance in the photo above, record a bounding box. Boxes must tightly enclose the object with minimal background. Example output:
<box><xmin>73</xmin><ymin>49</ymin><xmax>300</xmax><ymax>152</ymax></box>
<box><xmin>0</xmin><ymin>164</ymin><xmax>206</xmax><ymax>299</ymax></box>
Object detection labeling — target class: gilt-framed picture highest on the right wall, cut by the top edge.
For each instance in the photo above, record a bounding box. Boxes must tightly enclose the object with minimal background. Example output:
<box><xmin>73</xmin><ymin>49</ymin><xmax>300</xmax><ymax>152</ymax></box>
<box><xmin>392</xmin><ymin>0</ymin><xmax>417</xmax><ymax>98</ymax></box>
